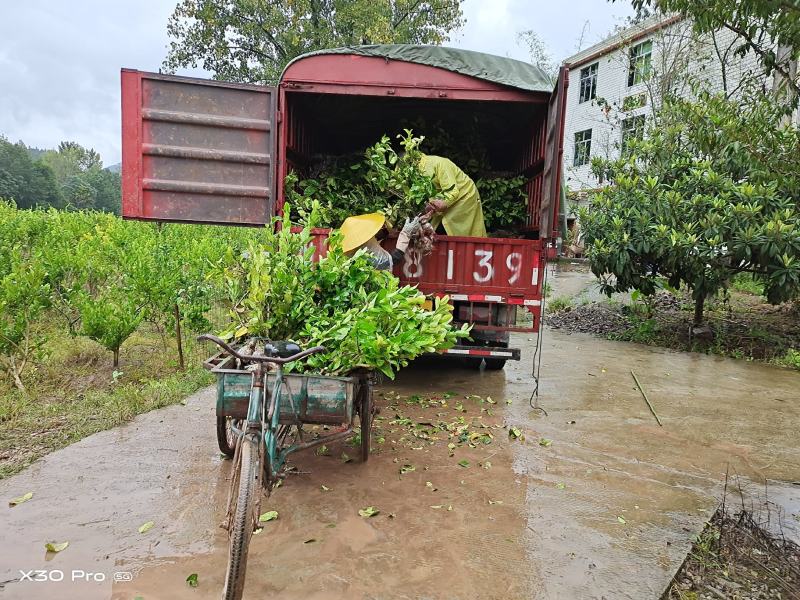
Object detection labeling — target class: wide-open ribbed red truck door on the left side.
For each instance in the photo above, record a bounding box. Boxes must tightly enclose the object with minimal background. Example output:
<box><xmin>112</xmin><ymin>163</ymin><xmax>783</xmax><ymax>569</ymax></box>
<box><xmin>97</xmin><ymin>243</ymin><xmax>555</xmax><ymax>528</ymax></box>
<box><xmin>122</xmin><ymin>69</ymin><xmax>277</xmax><ymax>225</ymax></box>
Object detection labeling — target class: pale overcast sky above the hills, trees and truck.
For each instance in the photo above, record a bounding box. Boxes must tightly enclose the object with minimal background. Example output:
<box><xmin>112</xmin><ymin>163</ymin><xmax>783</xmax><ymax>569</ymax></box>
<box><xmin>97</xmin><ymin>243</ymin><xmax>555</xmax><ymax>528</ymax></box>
<box><xmin>0</xmin><ymin>0</ymin><xmax>631</xmax><ymax>165</ymax></box>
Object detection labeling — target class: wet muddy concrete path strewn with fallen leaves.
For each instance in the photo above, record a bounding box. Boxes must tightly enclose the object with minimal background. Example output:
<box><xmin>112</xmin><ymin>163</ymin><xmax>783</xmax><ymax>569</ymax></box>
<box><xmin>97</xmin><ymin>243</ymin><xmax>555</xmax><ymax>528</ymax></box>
<box><xmin>0</xmin><ymin>308</ymin><xmax>800</xmax><ymax>600</ymax></box>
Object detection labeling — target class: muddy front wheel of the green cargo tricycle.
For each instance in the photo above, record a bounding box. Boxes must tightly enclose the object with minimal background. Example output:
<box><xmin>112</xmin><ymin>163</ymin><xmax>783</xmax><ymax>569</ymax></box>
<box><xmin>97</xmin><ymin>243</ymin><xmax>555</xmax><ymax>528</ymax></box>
<box><xmin>222</xmin><ymin>433</ymin><xmax>261</xmax><ymax>600</ymax></box>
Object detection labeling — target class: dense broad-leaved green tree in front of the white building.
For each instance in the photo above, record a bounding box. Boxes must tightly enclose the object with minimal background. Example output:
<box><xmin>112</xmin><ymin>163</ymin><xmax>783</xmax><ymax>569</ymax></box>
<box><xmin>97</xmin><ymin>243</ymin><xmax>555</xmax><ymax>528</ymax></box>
<box><xmin>581</xmin><ymin>92</ymin><xmax>800</xmax><ymax>326</ymax></box>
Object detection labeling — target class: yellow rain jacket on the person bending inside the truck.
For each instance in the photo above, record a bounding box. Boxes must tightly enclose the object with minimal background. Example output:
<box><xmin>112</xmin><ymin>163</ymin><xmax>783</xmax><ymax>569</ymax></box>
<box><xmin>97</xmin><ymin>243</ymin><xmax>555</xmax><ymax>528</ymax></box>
<box><xmin>419</xmin><ymin>154</ymin><xmax>486</xmax><ymax>237</ymax></box>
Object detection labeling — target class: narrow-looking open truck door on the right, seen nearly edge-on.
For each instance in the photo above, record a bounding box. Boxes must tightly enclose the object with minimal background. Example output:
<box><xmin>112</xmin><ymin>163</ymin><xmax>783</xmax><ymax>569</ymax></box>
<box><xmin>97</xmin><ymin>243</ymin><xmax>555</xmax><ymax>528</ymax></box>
<box><xmin>539</xmin><ymin>67</ymin><xmax>569</xmax><ymax>240</ymax></box>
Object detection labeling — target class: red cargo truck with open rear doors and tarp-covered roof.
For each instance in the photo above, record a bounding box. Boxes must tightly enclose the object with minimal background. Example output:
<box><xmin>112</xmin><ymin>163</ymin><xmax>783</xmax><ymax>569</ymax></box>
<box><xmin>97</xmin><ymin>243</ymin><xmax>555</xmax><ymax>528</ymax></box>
<box><xmin>122</xmin><ymin>45</ymin><xmax>567</xmax><ymax>369</ymax></box>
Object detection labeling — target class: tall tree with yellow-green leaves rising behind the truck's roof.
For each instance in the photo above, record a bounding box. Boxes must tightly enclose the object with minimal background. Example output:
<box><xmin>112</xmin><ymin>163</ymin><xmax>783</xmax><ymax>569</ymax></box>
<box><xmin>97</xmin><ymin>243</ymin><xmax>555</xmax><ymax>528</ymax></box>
<box><xmin>164</xmin><ymin>0</ymin><xmax>464</xmax><ymax>83</ymax></box>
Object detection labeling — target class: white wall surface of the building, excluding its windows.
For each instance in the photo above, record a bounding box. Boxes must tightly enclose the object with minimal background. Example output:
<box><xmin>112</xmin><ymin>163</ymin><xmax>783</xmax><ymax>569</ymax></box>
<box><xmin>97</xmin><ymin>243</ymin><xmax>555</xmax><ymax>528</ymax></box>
<box><xmin>564</xmin><ymin>20</ymin><xmax>771</xmax><ymax>198</ymax></box>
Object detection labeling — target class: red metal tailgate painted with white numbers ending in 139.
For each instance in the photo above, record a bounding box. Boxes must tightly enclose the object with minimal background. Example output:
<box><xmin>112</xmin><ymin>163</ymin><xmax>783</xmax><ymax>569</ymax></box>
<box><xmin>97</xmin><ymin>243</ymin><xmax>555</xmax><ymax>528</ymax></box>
<box><xmin>394</xmin><ymin>236</ymin><xmax>541</xmax><ymax>298</ymax></box>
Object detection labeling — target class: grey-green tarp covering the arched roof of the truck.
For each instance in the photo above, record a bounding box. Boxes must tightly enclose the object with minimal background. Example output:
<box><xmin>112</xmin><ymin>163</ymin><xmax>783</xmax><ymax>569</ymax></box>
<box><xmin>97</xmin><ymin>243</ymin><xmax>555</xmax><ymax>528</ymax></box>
<box><xmin>284</xmin><ymin>44</ymin><xmax>553</xmax><ymax>92</ymax></box>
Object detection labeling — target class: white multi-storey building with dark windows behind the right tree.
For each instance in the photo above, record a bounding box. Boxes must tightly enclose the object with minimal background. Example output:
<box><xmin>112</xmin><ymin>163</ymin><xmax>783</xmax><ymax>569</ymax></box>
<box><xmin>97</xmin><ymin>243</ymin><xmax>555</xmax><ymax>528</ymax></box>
<box><xmin>564</xmin><ymin>16</ymin><xmax>766</xmax><ymax>196</ymax></box>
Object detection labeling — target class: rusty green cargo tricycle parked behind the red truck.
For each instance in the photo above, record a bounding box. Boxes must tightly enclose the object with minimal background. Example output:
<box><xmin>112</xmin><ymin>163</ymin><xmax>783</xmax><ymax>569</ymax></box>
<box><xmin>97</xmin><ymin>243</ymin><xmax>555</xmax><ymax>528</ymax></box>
<box><xmin>200</xmin><ymin>335</ymin><xmax>373</xmax><ymax>600</ymax></box>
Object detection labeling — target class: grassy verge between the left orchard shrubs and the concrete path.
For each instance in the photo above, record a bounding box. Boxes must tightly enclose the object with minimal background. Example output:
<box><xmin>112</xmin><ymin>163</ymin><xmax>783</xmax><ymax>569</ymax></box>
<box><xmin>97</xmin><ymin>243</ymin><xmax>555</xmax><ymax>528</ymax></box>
<box><xmin>0</xmin><ymin>327</ymin><xmax>213</xmax><ymax>479</ymax></box>
